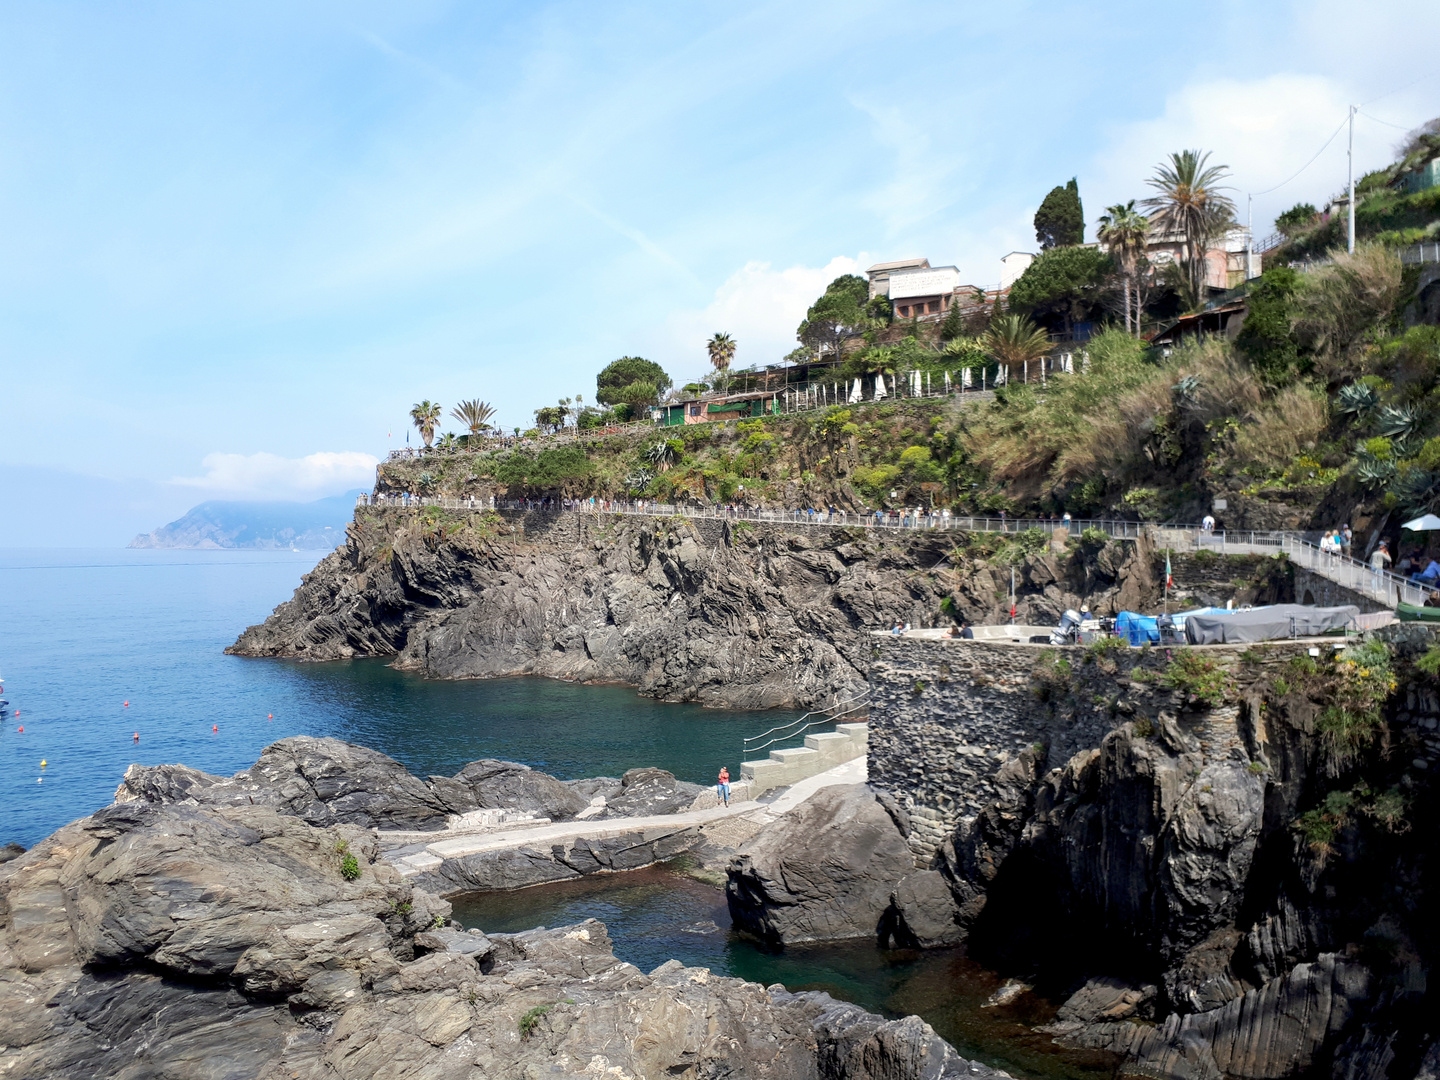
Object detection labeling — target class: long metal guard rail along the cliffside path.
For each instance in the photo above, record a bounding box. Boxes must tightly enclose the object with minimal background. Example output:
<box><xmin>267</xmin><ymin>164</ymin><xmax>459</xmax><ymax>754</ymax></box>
<box><xmin>356</xmin><ymin>495</ymin><xmax>1436</xmax><ymax>608</ymax></box>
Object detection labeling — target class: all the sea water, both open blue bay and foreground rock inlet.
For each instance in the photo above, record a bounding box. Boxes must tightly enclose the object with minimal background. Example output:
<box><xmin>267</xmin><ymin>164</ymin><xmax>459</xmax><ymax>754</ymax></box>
<box><xmin>0</xmin><ymin>549</ymin><xmax>1115</xmax><ymax>1080</ymax></box>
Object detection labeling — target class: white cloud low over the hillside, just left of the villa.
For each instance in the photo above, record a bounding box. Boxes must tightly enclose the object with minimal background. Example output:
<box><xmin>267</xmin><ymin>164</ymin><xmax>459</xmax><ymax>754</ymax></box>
<box><xmin>657</xmin><ymin>252</ymin><xmax>868</xmax><ymax>383</ymax></box>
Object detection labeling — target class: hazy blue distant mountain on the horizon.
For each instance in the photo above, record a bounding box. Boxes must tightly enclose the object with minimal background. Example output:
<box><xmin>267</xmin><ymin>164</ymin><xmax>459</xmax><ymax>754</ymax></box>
<box><xmin>130</xmin><ymin>491</ymin><xmax>359</xmax><ymax>550</ymax></box>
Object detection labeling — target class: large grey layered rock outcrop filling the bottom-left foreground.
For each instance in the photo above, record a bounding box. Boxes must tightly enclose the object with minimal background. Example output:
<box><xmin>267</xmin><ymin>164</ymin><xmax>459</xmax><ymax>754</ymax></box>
<box><xmin>0</xmin><ymin>747</ymin><xmax>1004</xmax><ymax>1080</ymax></box>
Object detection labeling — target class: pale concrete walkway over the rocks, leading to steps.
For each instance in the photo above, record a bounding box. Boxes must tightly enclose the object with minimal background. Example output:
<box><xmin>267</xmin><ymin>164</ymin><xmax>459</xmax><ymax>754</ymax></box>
<box><xmin>382</xmin><ymin>757</ymin><xmax>868</xmax><ymax>877</ymax></box>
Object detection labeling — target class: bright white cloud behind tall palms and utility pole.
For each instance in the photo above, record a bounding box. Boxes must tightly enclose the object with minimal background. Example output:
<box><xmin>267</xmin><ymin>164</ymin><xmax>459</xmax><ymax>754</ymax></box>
<box><xmin>1081</xmin><ymin>75</ymin><xmax>1398</xmax><ymax>235</ymax></box>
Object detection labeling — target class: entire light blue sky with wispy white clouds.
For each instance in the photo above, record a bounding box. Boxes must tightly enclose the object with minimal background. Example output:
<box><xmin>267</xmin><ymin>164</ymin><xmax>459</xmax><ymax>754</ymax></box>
<box><xmin>0</xmin><ymin>0</ymin><xmax>1440</xmax><ymax>547</ymax></box>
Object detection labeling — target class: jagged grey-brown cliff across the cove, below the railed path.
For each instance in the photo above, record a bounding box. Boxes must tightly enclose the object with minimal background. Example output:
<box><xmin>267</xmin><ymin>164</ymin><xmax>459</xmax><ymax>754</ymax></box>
<box><xmin>229</xmin><ymin>507</ymin><xmax>1203</xmax><ymax>708</ymax></box>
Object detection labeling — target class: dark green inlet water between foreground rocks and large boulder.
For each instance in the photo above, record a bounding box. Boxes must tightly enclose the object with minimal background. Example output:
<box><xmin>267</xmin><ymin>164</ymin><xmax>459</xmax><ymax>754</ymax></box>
<box><xmin>452</xmin><ymin>867</ymin><xmax>1115</xmax><ymax>1080</ymax></box>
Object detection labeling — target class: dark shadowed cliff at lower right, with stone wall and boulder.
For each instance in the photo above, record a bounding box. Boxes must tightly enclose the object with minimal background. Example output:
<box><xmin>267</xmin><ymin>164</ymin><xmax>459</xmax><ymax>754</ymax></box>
<box><xmin>729</xmin><ymin>628</ymin><xmax>1440</xmax><ymax>1080</ymax></box>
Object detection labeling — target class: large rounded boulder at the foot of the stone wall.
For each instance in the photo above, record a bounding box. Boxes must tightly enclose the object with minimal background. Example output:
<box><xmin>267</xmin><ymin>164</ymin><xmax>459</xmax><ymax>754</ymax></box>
<box><xmin>726</xmin><ymin>783</ymin><xmax>914</xmax><ymax>945</ymax></box>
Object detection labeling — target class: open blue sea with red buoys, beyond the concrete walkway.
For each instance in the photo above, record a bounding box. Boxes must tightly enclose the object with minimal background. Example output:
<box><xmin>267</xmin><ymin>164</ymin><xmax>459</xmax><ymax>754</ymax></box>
<box><xmin>0</xmin><ymin>549</ymin><xmax>795</xmax><ymax>847</ymax></box>
